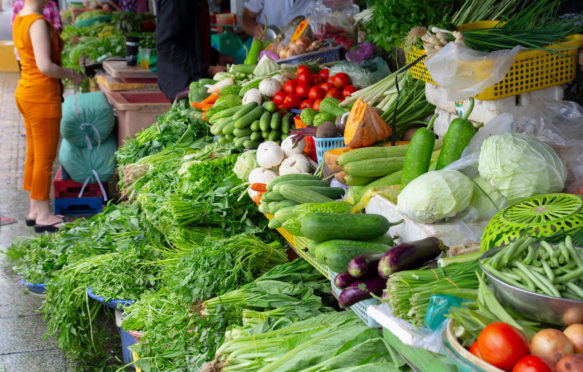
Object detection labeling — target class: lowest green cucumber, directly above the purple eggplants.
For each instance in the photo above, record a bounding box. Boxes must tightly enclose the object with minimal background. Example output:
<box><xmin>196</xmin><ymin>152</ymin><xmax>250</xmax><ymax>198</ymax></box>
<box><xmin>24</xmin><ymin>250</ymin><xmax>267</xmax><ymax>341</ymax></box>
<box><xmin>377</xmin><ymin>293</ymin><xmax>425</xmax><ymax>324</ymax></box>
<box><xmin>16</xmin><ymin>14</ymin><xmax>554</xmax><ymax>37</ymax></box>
<box><xmin>316</xmin><ymin>240</ymin><xmax>391</xmax><ymax>273</ymax></box>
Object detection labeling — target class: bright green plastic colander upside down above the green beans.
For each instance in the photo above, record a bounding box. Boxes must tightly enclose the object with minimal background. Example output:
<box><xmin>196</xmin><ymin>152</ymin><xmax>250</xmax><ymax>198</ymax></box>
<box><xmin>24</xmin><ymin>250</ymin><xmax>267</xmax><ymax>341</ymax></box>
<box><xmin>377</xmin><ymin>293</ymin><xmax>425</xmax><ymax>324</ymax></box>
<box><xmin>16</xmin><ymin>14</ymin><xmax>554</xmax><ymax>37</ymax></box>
<box><xmin>480</xmin><ymin>194</ymin><xmax>583</xmax><ymax>251</ymax></box>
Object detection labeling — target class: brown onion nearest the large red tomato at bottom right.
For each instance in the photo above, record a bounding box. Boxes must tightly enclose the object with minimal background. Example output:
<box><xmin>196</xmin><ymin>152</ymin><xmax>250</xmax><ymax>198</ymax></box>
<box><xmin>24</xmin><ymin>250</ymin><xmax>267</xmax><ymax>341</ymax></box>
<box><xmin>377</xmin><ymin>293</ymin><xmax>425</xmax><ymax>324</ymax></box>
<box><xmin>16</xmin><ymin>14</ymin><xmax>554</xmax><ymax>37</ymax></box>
<box><xmin>530</xmin><ymin>328</ymin><xmax>573</xmax><ymax>366</ymax></box>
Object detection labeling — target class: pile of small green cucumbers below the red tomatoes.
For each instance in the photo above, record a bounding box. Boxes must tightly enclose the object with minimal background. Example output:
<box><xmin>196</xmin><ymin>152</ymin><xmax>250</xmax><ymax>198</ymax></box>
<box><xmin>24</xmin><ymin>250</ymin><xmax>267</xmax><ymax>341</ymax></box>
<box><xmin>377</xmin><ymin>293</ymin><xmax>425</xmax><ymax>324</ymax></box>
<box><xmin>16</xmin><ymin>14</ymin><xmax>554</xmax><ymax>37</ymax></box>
<box><xmin>210</xmin><ymin>101</ymin><xmax>293</xmax><ymax>149</ymax></box>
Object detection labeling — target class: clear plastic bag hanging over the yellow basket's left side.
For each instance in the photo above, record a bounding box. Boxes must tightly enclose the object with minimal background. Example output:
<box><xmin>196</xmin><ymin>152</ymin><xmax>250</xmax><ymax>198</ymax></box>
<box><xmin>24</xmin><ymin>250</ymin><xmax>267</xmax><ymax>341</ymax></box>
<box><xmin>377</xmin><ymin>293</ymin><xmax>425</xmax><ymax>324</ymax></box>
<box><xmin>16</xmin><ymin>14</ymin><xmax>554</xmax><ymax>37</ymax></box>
<box><xmin>425</xmin><ymin>42</ymin><xmax>524</xmax><ymax>101</ymax></box>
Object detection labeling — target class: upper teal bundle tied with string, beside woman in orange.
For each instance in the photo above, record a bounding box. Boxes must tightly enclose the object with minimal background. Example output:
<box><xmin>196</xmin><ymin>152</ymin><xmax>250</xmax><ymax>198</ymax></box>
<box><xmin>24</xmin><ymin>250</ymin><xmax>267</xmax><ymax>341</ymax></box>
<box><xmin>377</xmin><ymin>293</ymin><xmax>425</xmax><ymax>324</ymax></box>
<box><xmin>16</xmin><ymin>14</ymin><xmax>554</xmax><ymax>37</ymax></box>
<box><xmin>61</xmin><ymin>92</ymin><xmax>115</xmax><ymax>149</ymax></box>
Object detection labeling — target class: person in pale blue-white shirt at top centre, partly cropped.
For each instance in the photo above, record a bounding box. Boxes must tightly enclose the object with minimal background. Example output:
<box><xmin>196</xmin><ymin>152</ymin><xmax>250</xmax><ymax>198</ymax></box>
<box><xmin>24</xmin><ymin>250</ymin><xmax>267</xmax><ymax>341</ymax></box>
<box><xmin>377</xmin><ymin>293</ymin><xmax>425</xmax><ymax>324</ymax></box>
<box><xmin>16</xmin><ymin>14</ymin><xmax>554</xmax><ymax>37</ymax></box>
<box><xmin>243</xmin><ymin>0</ymin><xmax>314</xmax><ymax>39</ymax></box>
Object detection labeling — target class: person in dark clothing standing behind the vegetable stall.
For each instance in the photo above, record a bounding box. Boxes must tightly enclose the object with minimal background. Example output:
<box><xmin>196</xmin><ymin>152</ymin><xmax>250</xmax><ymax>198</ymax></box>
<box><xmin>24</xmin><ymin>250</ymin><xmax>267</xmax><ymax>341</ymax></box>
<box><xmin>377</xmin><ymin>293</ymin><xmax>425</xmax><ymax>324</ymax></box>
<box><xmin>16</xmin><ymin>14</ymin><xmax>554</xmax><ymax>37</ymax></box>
<box><xmin>156</xmin><ymin>0</ymin><xmax>235</xmax><ymax>99</ymax></box>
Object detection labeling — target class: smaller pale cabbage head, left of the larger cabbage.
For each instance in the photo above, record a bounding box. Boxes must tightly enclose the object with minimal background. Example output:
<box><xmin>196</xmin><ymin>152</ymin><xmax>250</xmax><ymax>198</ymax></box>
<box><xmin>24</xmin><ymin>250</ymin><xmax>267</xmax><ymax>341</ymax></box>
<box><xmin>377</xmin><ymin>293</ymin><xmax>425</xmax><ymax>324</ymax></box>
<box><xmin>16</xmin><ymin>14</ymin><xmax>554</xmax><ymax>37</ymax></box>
<box><xmin>397</xmin><ymin>169</ymin><xmax>474</xmax><ymax>223</ymax></box>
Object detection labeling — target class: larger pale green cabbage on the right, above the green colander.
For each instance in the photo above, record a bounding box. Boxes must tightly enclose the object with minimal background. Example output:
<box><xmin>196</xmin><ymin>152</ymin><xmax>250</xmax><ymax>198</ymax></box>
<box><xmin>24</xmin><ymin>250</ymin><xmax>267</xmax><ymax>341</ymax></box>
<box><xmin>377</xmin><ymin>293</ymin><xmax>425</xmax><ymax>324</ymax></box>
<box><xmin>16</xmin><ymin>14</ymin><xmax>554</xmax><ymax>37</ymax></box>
<box><xmin>478</xmin><ymin>133</ymin><xmax>567</xmax><ymax>203</ymax></box>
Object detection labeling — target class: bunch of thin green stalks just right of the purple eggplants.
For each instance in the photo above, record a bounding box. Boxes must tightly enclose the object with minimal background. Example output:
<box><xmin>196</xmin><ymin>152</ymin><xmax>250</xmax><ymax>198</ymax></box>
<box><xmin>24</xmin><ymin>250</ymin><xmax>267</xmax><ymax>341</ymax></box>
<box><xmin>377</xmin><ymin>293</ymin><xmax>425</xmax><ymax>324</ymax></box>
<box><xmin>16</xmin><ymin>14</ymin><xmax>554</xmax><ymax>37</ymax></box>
<box><xmin>382</xmin><ymin>260</ymin><xmax>478</xmax><ymax>327</ymax></box>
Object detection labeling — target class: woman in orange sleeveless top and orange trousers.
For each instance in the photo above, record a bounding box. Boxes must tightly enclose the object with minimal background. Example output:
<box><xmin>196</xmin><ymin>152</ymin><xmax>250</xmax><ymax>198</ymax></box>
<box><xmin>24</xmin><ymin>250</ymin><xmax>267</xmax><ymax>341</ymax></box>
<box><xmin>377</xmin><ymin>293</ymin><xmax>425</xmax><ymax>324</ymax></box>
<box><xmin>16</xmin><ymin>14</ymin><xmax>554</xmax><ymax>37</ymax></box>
<box><xmin>12</xmin><ymin>0</ymin><xmax>83</xmax><ymax>232</ymax></box>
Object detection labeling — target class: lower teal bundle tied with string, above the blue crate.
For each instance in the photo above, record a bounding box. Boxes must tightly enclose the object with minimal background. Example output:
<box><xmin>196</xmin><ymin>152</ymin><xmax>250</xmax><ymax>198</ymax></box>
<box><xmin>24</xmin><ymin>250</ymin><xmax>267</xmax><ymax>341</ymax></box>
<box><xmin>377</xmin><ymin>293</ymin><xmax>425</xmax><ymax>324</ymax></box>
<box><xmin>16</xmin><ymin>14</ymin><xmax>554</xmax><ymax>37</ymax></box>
<box><xmin>59</xmin><ymin>136</ymin><xmax>117</xmax><ymax>201</ymax></box>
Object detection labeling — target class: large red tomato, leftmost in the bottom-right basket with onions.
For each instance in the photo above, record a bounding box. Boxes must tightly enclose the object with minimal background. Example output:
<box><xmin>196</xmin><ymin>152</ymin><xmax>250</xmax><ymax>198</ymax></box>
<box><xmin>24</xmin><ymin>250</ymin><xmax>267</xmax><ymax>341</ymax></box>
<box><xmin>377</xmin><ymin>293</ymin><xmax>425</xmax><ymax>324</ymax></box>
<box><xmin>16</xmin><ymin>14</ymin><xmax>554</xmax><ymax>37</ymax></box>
<box><xmin>477</xmin><ymin>322</ymin><xmax>530</xmax><ymax>371</ymax></box>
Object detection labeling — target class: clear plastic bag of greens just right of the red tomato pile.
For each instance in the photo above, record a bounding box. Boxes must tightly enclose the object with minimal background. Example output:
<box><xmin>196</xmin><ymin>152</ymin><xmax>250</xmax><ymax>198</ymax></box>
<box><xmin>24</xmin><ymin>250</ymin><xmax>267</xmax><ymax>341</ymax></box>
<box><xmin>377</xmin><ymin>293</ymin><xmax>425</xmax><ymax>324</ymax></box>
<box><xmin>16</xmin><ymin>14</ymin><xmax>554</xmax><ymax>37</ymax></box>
<box><xmin>330</xmin><ymin>57</ymin><xmax>391</xmax><ymax>88</ymax></box>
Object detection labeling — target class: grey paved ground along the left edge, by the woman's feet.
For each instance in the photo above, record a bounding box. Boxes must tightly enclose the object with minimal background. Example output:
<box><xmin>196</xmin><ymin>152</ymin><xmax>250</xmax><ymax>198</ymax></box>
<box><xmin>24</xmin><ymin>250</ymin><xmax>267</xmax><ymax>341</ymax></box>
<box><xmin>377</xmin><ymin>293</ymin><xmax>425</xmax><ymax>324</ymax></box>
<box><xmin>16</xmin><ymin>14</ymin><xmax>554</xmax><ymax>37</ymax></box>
<box><xmin>0</xmin><ymin>70</ymin><xmax>67</xmax><ymax>372</ymax></box>
